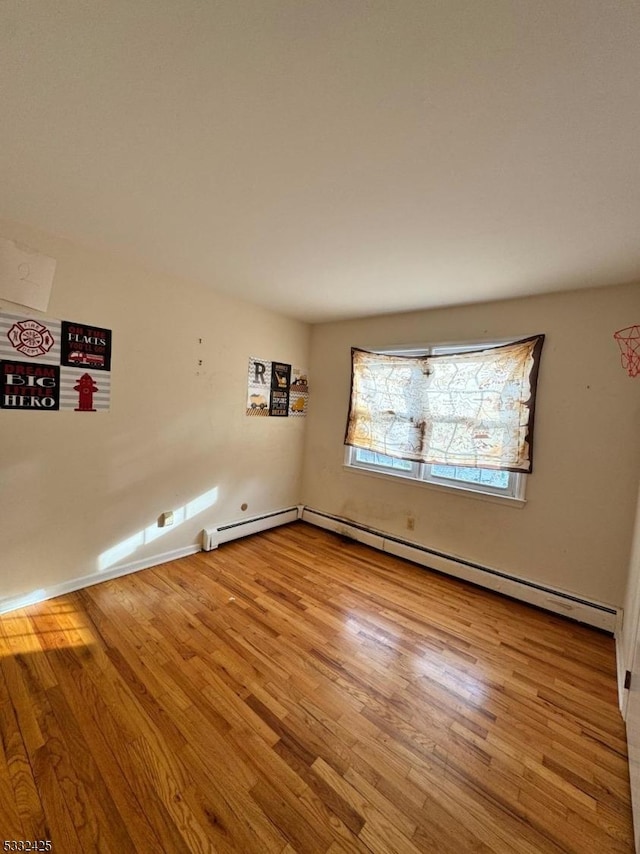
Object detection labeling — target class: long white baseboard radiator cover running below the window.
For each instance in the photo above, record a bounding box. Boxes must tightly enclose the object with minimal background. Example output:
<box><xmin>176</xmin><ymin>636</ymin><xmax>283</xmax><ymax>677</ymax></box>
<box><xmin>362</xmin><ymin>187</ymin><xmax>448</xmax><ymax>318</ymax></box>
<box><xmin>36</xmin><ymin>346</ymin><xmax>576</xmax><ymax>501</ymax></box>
<box><xmin>301</xmin><ymin>507</ymin><xmax>622</xmax><ymax>635</ymax></box>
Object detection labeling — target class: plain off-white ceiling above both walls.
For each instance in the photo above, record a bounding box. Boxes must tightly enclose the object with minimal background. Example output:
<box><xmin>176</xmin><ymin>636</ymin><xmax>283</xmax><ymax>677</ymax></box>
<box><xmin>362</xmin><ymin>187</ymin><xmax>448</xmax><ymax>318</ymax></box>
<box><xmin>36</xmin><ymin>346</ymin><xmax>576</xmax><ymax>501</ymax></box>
<box><xmin>0</xmin><ymin>0</ymin><xmax>640</xmax><ymax>320</ymax></box>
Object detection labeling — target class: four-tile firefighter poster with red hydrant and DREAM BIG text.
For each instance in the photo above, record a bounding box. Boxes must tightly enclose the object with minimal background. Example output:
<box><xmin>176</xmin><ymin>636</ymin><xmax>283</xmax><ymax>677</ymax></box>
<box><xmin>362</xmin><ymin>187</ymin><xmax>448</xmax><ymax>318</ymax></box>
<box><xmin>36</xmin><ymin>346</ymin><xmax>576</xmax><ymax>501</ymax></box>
<box><xmin>0</xmin><ymin>313</ymin><xmax>111</xmax><ymax>412</ymax></box>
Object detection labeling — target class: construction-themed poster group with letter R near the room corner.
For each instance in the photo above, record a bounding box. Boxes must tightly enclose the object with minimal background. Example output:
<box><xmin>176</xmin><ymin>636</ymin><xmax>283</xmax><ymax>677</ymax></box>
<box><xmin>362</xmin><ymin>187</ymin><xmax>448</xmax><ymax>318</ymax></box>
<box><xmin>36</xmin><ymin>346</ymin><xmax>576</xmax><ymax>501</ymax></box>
<box><xmin>247</xmin><ymin>357</ymin><xmax>309</xmax><ymax>418</ymax></box>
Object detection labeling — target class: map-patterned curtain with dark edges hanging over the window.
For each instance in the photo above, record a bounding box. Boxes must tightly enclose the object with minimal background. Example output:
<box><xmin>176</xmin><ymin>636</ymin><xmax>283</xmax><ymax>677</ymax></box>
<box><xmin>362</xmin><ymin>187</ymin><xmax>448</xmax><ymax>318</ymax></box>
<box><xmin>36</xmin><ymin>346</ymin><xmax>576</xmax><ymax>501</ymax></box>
<box><xmin>345</xmin><ymin>335</ymin><xmax>544</xmax><ymax>472</ymax></box>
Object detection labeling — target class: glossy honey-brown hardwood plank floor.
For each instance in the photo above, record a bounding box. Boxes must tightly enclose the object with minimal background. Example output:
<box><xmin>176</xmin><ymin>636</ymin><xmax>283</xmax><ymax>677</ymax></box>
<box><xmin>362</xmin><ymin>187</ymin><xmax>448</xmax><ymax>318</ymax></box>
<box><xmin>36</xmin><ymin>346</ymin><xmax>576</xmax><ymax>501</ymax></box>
<box><xmin>0</xmin><ymin>522</ymin><xmax>633</xmax><ymax>854</ymax></box>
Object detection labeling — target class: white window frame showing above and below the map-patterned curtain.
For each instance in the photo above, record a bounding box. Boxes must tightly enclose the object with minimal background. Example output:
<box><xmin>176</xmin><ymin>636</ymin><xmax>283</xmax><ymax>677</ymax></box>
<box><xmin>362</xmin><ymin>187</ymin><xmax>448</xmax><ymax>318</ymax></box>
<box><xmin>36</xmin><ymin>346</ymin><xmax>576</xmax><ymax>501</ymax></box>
<box><xmin>344</xmin><ymin>339</ymin><xmax>527</xmax><ymax>506</ymax></box>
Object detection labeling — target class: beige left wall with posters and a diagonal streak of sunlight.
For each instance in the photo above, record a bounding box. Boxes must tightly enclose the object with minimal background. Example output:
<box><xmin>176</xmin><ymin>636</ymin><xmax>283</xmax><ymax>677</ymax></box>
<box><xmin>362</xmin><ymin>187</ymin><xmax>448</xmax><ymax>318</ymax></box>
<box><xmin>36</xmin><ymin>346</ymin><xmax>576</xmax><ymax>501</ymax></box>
<box><xmin>0</xmin><ymin>221</ymin><xmax>309</xmax><ymax>605</ymax></box>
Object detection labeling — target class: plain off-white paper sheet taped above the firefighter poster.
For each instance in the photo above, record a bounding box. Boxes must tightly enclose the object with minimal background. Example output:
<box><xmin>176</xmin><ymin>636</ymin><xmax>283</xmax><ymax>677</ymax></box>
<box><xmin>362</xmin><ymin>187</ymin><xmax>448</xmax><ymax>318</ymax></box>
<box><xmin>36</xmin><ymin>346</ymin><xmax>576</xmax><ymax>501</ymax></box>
<box><xmin>0</xmin><ymin>237</ymin><xmax>56</xmax><ymax>311</ymax></box>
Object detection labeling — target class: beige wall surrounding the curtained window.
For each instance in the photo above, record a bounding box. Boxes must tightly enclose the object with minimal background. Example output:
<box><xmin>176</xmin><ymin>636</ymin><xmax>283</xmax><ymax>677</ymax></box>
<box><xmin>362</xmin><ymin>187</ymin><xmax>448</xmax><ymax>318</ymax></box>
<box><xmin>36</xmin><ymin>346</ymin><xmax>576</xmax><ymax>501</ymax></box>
<box><xmin>303</xmin><ymin>286</ymin><xmax>640</xmax><ymax>606</ymax></box>
